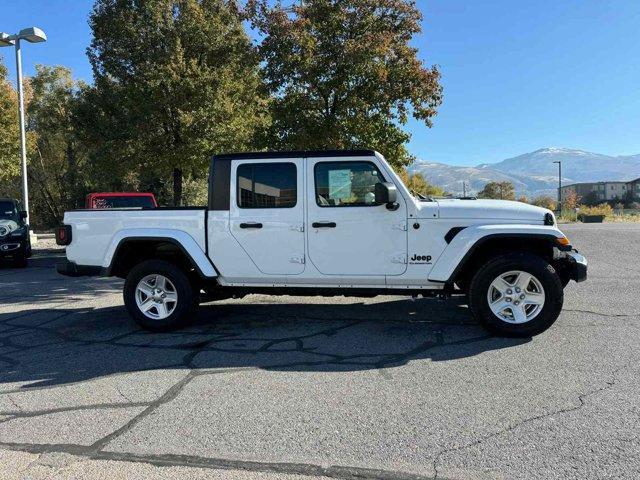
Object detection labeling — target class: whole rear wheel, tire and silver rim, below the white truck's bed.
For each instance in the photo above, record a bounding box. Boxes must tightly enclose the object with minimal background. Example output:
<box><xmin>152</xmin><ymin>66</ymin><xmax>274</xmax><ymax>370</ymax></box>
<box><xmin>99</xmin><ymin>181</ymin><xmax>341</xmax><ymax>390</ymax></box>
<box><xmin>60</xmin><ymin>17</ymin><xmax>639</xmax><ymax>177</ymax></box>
<box><xmin>123</xmin><ymin>260</ymin><xmax>197</xmax><ymax>331</ymax></box>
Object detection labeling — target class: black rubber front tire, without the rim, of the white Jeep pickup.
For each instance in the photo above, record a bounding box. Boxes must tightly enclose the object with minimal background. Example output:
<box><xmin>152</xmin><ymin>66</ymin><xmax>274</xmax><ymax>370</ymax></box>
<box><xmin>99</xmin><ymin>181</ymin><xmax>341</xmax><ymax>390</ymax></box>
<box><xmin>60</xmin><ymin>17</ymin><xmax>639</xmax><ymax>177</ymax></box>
<box><xmin>468</xmin><ymin>253</ymin><xmax>564</xmax><ymax>337</ymax></box>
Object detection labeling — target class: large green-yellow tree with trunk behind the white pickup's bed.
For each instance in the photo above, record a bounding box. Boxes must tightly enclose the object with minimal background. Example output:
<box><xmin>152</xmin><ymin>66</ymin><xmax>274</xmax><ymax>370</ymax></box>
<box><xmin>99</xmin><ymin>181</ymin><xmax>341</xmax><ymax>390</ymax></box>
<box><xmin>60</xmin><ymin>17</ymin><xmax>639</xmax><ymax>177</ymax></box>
<box><xmin>79</xmin><ymin>0</ymin><xmax>267</xmax><ymax>205</ymax></box>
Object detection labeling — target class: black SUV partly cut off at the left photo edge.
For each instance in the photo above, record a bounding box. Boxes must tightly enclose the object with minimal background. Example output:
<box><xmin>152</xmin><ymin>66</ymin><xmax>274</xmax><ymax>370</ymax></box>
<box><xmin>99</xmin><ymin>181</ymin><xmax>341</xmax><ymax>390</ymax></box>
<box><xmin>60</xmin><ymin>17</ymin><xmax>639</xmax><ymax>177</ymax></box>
<box><xmin>0</xmin><ymin>198</ymin><xmax>31</xmax><ymax>267</ymax></box>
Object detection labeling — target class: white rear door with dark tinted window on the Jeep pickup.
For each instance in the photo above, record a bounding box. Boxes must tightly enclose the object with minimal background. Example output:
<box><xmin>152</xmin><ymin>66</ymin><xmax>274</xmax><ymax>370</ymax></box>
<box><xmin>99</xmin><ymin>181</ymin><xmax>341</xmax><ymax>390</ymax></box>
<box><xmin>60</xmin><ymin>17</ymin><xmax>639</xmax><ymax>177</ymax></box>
<box><xmin>229</xmin><ymin>158</ymin><xmax>305</xmax><ymax>275</ymax></box>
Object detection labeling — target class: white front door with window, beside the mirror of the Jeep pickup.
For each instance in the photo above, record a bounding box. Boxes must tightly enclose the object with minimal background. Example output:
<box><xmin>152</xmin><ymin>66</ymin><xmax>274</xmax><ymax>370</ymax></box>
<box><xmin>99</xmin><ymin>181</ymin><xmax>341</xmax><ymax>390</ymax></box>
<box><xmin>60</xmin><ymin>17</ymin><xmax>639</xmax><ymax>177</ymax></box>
<box><xmin>307</xmin><ymin>158</ymin><xmax>407</xmax><ymax>276</ymax></box>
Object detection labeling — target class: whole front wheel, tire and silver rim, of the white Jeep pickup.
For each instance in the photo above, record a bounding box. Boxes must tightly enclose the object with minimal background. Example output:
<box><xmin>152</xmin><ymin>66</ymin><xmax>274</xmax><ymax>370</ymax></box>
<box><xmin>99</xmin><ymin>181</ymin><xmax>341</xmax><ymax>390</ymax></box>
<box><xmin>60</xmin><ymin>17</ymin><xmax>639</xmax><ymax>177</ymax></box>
<box><xmin>469</xmin><ymin>253</ymin><xmax>564</xmax><ymax>337</ymax></box>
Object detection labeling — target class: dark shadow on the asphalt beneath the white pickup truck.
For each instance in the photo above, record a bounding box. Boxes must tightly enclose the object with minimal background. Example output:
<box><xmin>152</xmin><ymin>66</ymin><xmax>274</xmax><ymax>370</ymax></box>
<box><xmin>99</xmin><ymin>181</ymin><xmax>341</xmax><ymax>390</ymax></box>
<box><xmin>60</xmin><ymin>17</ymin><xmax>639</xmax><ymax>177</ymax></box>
<box><xmin>0</xmin><ymin>297</ymin><xmax>530</xmax><ymax>389</ymax></box>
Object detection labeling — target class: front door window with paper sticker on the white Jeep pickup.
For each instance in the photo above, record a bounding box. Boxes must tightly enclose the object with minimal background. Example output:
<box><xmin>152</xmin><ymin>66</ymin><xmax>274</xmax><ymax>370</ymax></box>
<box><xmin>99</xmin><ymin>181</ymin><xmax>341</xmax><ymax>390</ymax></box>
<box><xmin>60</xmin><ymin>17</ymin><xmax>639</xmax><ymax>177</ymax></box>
<box><xmin>314</xmin><ymin>162</ymin><xmax>385</xmax><ymax>207</ymax></box>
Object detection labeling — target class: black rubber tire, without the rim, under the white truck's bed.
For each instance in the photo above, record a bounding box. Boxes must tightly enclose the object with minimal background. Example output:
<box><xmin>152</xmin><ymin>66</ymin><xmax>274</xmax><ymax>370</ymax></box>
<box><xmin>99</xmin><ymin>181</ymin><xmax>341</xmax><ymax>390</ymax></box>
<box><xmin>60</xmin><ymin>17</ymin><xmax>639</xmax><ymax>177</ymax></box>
<box><xmin>123</xmin><ymin>260</ymin><xmax>198</xmax><ymax>332</ymax></box>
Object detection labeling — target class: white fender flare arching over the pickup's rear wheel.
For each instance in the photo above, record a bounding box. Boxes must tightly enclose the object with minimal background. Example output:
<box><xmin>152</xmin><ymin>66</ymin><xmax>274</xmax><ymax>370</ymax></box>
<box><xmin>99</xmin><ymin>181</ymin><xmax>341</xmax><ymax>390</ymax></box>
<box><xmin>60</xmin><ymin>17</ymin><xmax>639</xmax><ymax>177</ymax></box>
<box><xmin>102</xmin><ymin>228</ymin><xmax>218</xmax><ymax>278</ymax></box>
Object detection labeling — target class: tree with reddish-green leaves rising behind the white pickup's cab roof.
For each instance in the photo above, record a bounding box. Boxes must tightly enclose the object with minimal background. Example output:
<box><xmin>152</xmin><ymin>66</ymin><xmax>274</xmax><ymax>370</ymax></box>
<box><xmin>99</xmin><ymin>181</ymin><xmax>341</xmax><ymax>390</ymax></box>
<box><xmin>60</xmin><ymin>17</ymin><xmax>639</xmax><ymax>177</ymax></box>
<box><xmin>248</xmin><ymin>0</ymin><xmax>442</xmax><ymax>167</ymax></box>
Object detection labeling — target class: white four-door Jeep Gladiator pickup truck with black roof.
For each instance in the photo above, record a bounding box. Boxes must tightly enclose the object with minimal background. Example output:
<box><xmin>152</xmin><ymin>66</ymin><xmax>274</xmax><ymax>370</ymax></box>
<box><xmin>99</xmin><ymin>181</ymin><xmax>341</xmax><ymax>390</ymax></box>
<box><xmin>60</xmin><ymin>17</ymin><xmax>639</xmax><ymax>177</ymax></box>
<box><xmin>57</xmin><ymin>150</ymin><xmax>587</xmax><ymax>336</ymax></box>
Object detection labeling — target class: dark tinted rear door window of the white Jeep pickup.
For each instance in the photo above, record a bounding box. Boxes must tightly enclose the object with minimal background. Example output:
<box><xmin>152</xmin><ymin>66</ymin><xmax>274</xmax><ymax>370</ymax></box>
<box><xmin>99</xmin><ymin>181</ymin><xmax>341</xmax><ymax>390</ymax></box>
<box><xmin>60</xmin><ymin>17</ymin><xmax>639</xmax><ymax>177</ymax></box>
<box><xmin>236</xmin><ymin>163</ymin><xmax>298</xmax><ymax>208</ymax></box>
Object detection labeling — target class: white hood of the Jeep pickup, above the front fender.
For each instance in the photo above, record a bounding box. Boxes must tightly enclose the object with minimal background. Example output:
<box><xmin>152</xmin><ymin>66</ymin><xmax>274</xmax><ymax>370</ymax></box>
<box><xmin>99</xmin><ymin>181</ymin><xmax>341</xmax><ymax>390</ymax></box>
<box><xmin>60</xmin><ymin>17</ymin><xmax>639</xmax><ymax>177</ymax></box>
<box><xmin>430</xmin><ymin>198</ymin><xmax>551</xmax><ymax>223</ymax></box>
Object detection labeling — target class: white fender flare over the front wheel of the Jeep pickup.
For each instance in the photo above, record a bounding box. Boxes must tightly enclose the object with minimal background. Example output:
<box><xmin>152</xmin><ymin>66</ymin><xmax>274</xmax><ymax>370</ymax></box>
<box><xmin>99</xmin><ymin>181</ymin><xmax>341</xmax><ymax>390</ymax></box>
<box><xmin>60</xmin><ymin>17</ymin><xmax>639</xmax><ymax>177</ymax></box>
<box><xmin>428</xmin><ymin>224</ymin><xmax>564</xmax><ymax>283</ymax></box>
